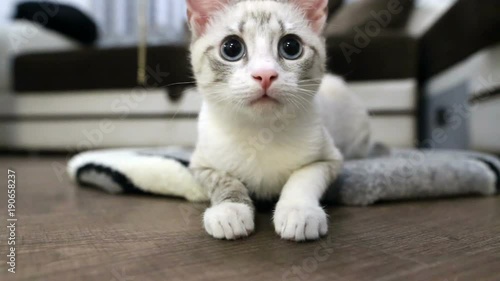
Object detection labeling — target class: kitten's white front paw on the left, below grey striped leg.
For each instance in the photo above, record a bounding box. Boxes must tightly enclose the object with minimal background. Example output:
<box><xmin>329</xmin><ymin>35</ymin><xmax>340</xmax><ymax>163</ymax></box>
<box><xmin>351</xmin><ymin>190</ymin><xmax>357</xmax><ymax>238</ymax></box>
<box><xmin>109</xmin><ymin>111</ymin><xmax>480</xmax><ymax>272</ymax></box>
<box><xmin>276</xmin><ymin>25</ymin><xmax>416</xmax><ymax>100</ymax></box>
<box><xmin>203</xmin><ymin>202</ymin><xmax>255</xmax><ymax>240</ymax></box>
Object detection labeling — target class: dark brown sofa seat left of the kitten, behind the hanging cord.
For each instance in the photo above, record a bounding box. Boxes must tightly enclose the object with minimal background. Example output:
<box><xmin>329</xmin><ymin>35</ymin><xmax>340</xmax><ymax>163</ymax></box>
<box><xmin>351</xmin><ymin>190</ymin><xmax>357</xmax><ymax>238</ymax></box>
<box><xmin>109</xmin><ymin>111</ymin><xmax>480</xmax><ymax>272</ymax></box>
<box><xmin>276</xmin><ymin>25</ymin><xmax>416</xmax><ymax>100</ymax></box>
<box><xmin>14</xmin><ymin>46</ymin><xmax>192</xmax><ymax>92</ymax></box>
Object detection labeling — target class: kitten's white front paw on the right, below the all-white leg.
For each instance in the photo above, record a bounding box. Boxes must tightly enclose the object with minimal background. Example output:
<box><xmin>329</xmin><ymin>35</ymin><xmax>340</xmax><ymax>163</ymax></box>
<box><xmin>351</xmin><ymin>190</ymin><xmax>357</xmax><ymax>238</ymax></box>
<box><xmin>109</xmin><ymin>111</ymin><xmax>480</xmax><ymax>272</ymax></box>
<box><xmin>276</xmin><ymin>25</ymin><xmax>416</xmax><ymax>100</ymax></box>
<box><xmin>274</xmin><ymin>204</ymin><xmax>328</xmax><ymax>241</ymax></box>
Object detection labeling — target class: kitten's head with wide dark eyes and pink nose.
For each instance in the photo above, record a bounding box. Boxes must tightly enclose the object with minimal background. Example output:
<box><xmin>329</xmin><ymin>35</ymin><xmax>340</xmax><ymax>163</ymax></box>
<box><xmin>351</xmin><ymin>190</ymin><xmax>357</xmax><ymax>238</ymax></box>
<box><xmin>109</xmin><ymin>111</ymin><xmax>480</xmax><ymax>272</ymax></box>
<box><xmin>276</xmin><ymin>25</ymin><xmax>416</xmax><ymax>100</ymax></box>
<box><xmin>187</xmin><ymin>0</ymin><xmax>328</xmax><ymax>116</ymax></box>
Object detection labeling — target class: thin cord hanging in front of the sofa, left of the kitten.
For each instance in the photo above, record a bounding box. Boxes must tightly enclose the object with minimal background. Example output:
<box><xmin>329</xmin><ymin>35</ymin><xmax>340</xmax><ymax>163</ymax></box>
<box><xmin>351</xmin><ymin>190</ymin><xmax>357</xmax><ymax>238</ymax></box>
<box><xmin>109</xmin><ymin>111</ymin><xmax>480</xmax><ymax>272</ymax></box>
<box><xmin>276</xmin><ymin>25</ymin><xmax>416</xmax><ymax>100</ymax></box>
<box><xmin>137</xmin><ymin>0</ymin><xmax>149</xmax><ymax>86</ymax></box>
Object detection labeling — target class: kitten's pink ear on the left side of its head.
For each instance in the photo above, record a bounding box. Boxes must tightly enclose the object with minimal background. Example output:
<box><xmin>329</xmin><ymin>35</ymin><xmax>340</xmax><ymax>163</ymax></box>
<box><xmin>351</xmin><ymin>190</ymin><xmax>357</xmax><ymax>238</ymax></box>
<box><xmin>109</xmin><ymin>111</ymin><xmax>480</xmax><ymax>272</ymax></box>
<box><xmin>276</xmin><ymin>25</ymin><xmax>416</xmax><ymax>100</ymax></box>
<box><xmin>187</xmin><ymin>0</ymin><xmax>230</xmax><ymax>36</ymax></box>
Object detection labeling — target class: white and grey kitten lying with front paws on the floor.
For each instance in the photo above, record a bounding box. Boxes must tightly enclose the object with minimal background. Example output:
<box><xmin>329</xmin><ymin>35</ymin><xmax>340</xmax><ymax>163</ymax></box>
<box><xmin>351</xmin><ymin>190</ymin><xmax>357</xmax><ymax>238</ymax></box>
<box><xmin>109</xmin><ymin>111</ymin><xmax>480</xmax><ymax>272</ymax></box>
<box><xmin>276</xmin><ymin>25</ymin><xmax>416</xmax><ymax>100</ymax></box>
<box><xmin>187</xmin><ymin>0</ymin><xmax>370</xmax><ymax>241</ymax></box>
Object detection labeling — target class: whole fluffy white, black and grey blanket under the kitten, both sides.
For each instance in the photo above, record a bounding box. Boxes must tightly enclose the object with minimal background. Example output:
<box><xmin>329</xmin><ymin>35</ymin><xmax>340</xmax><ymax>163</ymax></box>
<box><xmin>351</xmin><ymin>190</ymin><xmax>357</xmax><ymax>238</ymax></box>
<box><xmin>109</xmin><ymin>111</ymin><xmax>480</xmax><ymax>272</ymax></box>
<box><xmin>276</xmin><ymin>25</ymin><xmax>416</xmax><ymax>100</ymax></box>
<box><xmin>68</xmin><ymin>147</ymin><xmax>500</xmax><ymax>206</ymax></box>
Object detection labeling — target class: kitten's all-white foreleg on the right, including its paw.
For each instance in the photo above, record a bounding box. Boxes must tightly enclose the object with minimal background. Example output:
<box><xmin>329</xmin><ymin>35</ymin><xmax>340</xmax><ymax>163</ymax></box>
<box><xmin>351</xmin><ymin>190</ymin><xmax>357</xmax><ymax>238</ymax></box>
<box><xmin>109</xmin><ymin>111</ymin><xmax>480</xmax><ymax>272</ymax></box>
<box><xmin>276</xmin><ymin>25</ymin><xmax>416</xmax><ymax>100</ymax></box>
<box><xmin>274</xmin><ymin>161</ymin><xmax>340</xmax><ymax>241</ymax></box>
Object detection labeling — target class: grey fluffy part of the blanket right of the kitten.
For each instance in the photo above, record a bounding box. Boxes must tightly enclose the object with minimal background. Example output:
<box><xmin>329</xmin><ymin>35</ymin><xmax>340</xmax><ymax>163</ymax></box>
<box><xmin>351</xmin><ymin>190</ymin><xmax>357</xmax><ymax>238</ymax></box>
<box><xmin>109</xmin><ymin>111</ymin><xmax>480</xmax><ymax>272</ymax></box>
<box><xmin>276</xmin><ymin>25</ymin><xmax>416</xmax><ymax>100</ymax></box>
<box><xmin>324</xmin><ymin>150</ymin><xmax>500</xmax><ymax>205</ymax></box>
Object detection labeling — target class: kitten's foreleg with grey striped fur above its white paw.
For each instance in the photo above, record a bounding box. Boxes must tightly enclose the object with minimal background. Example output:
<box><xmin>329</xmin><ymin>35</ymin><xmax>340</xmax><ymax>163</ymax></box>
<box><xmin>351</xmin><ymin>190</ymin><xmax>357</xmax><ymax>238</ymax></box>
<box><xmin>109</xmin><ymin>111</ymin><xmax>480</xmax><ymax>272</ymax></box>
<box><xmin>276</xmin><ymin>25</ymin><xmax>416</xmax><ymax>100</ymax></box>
<box><xmin>192</xmin><ymin>168</ymin><xmax>255</xmax><ymax>240</ymax></box>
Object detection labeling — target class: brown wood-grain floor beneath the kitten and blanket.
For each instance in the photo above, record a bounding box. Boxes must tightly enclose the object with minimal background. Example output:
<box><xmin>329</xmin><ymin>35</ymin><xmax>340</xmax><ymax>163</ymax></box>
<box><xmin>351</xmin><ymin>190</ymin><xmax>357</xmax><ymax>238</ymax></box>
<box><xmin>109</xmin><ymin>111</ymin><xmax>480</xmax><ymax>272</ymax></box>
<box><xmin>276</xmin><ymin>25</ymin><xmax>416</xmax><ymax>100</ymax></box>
<box><xmin>0</xmin><ymin>157</ymin><xmax>500</xmax><ymax>281</ymax></box>
